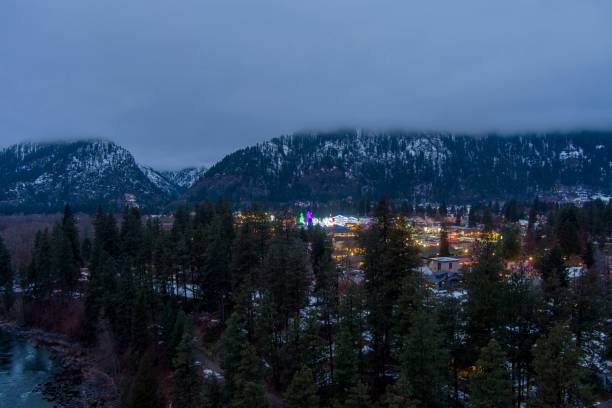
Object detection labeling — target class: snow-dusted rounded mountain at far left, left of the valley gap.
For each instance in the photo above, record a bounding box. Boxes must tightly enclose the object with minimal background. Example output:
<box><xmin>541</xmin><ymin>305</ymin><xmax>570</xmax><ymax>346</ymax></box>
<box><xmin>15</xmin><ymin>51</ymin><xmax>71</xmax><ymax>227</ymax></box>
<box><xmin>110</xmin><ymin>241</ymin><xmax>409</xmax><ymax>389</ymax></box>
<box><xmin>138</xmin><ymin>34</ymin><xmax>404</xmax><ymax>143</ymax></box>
<box><xmin>0</xmin><ymin>140</ymin><xmax>178</xmax><ymax>212</ymax></box>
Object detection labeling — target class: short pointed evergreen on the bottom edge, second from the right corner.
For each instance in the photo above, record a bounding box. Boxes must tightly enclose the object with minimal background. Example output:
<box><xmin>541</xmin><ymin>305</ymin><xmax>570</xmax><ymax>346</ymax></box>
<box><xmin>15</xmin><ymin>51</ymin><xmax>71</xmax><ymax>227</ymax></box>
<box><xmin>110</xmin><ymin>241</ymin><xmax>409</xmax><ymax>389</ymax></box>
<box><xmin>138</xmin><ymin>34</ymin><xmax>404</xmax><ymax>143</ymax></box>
<box><xmin>470</xmin><ymin>339</ymin><xmax>513</xmax><ymax>408</ymax></box>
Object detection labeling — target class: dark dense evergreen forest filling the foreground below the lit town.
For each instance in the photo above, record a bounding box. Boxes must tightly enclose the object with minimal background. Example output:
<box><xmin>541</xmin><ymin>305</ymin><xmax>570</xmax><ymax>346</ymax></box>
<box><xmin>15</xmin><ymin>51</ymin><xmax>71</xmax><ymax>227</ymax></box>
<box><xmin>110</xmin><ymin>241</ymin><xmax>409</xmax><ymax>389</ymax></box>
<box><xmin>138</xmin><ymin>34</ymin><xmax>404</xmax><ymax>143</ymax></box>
<box><xmin>0</xmin><ymin>200</ymin><xmax>612</xmax><ymax>408</ymax></box>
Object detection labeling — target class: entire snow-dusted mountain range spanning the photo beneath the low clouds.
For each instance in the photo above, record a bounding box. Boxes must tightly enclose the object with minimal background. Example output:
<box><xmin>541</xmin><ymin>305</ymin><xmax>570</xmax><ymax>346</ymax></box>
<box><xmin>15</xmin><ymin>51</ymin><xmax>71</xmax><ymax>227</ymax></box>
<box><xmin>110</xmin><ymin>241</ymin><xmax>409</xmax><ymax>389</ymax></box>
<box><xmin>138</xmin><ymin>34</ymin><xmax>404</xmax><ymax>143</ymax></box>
<box><xmin>0</xmin><ymin>129</ymin><xmax>612</xmax><ymax>213</ymax></box>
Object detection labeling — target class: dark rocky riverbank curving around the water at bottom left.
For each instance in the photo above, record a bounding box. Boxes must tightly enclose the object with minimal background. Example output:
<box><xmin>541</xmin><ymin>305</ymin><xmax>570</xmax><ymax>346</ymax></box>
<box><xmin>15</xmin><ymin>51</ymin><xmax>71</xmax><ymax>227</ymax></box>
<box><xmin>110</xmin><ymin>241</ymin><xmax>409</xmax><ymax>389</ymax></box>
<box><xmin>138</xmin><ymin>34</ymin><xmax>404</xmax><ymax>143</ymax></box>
<box><xmin>0</xmin><ymin>321</ymin><xmax>119</xmax><ymax>408</ymax></box>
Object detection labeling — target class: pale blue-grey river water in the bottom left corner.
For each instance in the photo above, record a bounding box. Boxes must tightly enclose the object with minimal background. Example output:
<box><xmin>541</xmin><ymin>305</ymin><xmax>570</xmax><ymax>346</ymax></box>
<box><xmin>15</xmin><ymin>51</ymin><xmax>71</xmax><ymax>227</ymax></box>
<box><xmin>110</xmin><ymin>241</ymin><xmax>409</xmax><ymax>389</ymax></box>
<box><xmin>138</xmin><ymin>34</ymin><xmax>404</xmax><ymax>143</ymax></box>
<box><xmin>0</xmin><ymin>330</ymin><xmax>54</xmax><ymax>408</ymax></box>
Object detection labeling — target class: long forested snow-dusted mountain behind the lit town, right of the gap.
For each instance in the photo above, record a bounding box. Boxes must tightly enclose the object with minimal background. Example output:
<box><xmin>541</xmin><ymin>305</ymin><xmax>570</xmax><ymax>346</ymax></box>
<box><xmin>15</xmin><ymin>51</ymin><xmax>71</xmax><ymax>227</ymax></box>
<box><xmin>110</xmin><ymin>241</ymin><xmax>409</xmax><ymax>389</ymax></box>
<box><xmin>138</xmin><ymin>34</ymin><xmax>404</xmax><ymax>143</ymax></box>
<box><xmin>186</xmin><ymin>130</ymin><xmax>612</xmax><ymax>204</ymax></box>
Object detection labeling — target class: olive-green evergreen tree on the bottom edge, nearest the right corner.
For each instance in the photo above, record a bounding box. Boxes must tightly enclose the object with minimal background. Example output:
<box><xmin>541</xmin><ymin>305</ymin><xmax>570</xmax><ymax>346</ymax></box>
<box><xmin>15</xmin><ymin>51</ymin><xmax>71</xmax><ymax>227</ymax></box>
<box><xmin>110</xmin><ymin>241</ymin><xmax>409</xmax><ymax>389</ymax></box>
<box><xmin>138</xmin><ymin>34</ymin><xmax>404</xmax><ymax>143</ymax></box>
<box><xmin>533</xmin><ymin>324</ymin><xmax>593</xmax><ymax>408</ymax></box>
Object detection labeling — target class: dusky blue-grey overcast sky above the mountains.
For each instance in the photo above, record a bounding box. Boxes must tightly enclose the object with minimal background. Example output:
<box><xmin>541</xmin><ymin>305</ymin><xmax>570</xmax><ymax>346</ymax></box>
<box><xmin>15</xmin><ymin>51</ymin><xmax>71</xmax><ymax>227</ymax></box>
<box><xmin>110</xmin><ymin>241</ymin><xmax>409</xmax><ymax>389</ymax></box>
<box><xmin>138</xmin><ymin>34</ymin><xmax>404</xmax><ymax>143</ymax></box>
<box><xmin>0</xmin><ymin>0</ymin><xmax>612</xmax><ymax>169</ymax></box>
